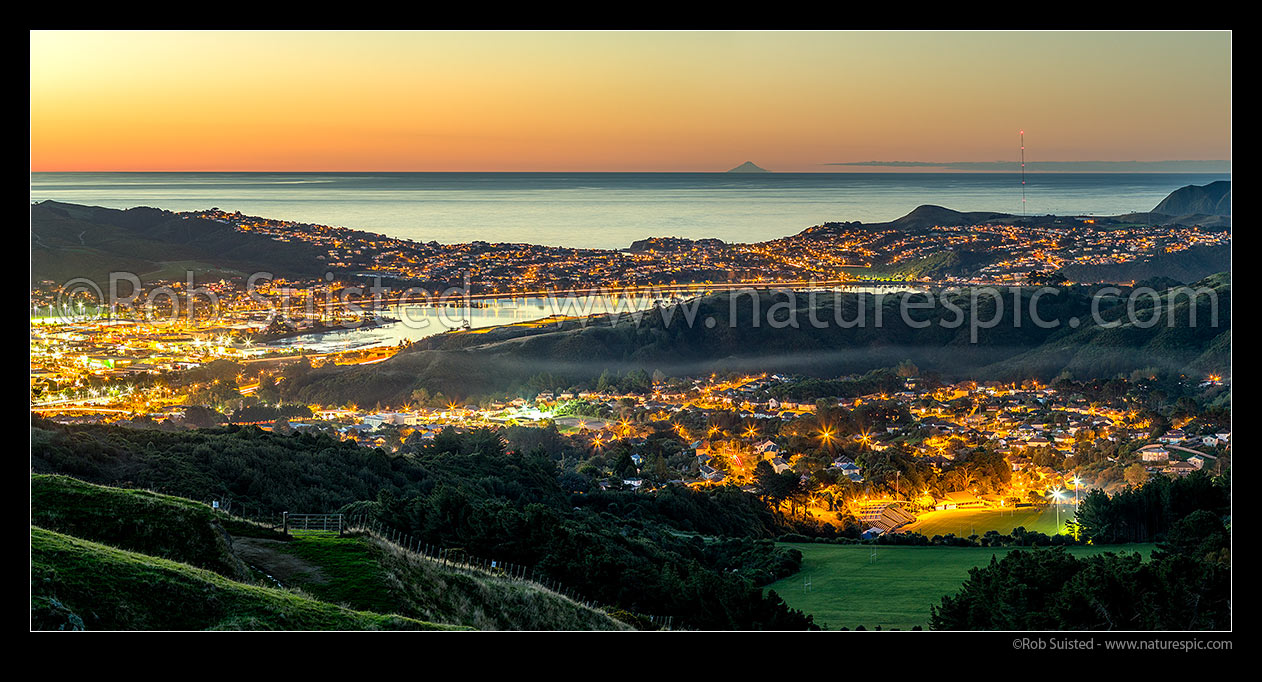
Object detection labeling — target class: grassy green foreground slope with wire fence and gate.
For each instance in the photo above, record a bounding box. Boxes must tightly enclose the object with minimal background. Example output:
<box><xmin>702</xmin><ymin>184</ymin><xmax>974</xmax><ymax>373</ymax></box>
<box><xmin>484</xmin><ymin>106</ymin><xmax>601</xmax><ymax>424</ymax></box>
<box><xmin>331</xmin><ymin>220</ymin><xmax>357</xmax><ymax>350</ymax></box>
<box><xmin>30</xmin><ymin>475</ymin><xmax>632</xmax><ymax>630</ymax></box>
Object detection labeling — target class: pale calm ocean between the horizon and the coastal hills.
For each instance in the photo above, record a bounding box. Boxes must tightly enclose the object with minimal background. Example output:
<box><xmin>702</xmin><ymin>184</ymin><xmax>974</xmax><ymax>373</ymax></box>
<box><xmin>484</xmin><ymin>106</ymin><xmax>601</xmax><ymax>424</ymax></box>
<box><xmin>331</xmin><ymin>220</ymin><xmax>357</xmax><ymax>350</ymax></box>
<box><xmin>30</xmin><ymin>173</ymin><xmax>1230</xmax><ymax>249</ymax></box>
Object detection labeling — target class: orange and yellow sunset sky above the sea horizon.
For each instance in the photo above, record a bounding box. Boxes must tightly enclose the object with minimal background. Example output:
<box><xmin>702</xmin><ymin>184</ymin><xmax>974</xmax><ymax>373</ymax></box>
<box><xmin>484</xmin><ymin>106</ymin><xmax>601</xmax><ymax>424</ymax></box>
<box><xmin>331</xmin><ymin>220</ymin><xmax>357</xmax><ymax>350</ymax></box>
<box><xmin>30</xmin><ymin>32</ymin><xmax>1232</xmax><ymax>172</ymax></box>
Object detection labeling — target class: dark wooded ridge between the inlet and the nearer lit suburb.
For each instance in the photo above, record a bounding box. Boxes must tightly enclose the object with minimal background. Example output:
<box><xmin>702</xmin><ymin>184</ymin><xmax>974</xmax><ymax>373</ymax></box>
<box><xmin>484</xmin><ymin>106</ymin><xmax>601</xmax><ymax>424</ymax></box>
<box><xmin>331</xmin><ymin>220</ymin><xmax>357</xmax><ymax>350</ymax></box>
<box><xmin>278</xmin><ymin>274</ymin><xmax>1230</xmax><ymax>404</ymax></box>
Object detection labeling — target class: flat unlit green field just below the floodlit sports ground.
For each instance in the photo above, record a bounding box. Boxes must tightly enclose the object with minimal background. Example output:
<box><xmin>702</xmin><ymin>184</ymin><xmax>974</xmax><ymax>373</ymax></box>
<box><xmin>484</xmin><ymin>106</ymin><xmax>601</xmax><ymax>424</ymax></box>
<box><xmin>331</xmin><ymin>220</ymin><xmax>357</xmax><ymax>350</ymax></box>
<box><xmin>770</xmin><ymin>543</ymin><xmax>1152</xmax><ymax>630</ymax></box>
